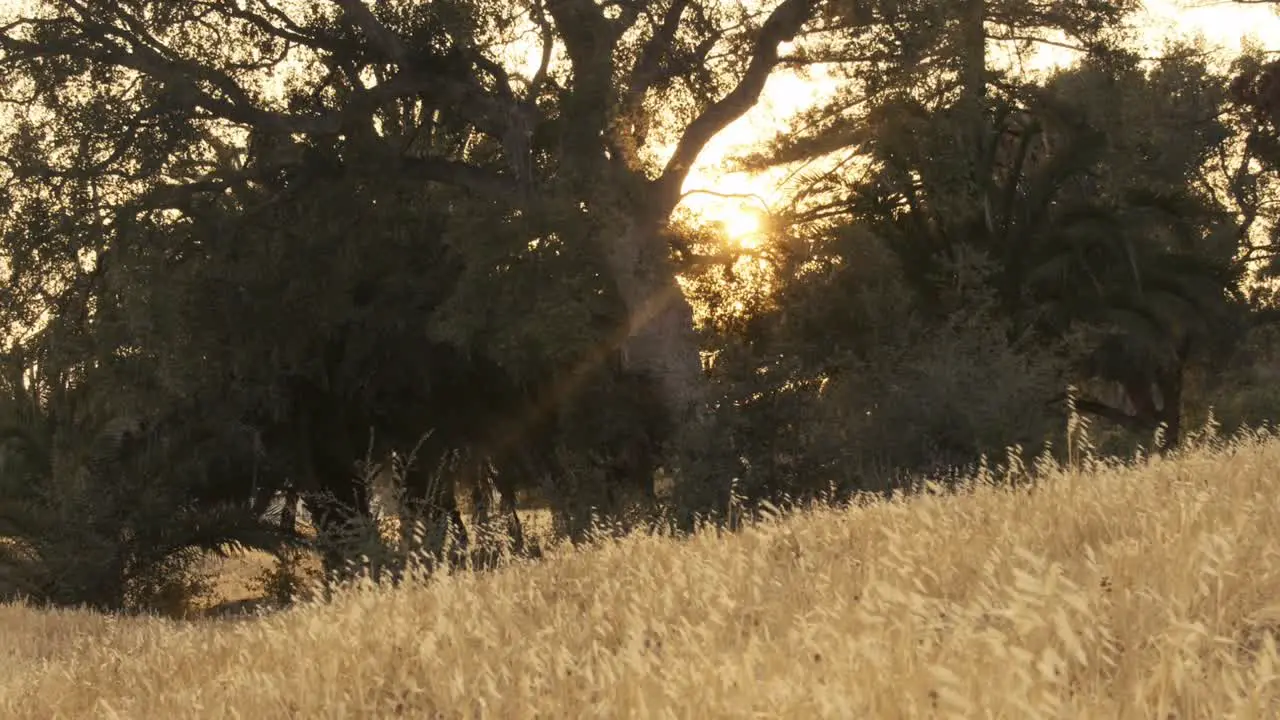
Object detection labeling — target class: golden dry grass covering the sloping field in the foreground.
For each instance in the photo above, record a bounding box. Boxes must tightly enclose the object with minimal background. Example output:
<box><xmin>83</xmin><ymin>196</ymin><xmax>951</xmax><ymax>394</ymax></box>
<box><xmin>0</xmin><ymin>427</ymin><xmax>1280</xmax><ymax>720</ymax></box>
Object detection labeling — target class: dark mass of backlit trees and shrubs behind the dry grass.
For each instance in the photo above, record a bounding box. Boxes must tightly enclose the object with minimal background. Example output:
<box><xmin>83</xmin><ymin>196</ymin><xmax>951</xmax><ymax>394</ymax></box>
<box><xmin>0</xmin><ymin>0</ymin><xmax>1280</xmax><ymax>609</ymax></box>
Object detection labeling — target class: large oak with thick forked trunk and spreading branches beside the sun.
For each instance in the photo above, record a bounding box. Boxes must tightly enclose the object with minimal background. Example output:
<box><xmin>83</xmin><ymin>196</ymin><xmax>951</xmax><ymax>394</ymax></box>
<box><xmin>0</xmin><ymin>0</ymin><xmax>834</xmax><ymax>504</ymax></box>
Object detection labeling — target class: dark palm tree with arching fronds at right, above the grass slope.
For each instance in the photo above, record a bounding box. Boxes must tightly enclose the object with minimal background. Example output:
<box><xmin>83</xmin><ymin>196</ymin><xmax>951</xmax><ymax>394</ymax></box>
<box><xmin>852</xmin><ymin>94</ymin><xmax>1238</xmax><ymax>447</ymax></box>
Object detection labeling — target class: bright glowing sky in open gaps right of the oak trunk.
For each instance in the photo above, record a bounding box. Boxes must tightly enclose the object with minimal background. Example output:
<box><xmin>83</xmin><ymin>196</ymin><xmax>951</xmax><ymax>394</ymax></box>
<box><xmin>682</xmin><ymin>0</ymin><xmax>1280</xmax><ymax>246</ymax></box>
